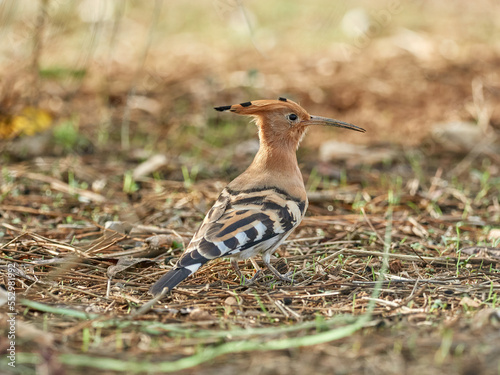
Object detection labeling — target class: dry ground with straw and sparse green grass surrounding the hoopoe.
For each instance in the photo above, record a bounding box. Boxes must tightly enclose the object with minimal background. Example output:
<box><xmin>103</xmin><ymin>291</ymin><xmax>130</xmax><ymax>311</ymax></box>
<box><xmin>0</xmin><ymin>1</ymin><xmax>500</xmax><ymax>374</ymax></box>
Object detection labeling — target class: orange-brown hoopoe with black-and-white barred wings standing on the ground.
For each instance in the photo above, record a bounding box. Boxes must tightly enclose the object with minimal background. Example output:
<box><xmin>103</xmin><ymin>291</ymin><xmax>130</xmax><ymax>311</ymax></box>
<box><xmin>149</xmin><ymin>97</ymin><xmax>365</xmax><ymax>296</ymax></box>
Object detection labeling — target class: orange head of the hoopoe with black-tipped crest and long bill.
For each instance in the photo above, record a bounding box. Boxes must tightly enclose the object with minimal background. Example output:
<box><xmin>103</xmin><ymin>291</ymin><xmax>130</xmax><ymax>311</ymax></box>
<box><xmin>214</xmin><ymin>98</ymin><xmax>365</xmax><ymax>149</ymax></box>
